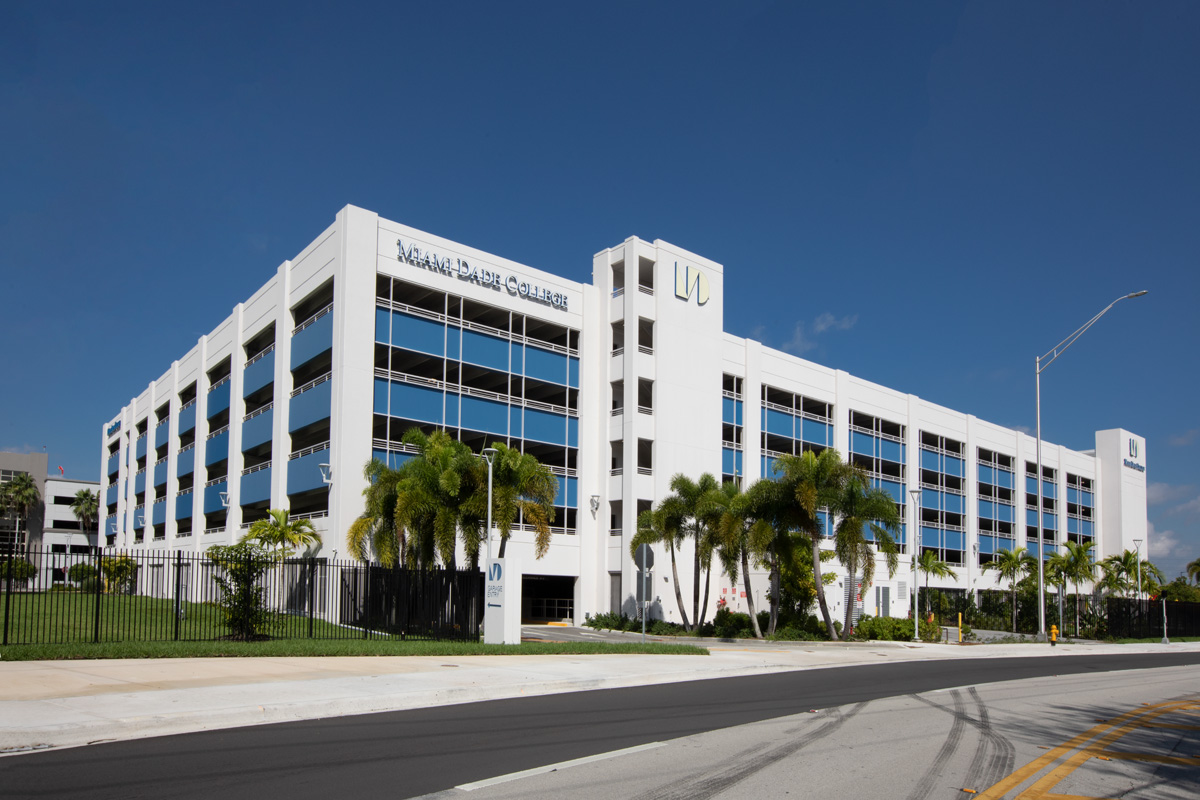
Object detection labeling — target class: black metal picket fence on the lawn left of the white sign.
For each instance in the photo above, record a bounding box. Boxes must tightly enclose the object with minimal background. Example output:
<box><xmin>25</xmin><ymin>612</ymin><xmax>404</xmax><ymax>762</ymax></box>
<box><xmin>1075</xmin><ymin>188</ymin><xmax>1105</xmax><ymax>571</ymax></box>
<box><xmin>0</xmin><ymin>547</ymin><xmax>484</xmax><ymax>645</ymax></box>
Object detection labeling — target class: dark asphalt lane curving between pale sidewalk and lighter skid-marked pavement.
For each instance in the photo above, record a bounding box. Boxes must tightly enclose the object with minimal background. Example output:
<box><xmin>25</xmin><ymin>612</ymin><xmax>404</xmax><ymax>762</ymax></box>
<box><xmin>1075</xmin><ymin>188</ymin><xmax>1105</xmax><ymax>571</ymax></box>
<box><xmin>0</xmin><ymin>652</ymin><xmax>1200</xmax><ymax>800</ymax></box>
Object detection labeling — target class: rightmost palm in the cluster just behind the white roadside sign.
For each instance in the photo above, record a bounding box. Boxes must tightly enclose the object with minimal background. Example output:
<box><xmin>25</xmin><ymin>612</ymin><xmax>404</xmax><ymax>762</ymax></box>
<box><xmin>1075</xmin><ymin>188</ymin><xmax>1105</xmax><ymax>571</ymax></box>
<box><xmin>475</xmin><ymin>441</ymin><xmax>558</xmax><ymax>558</ymax></box>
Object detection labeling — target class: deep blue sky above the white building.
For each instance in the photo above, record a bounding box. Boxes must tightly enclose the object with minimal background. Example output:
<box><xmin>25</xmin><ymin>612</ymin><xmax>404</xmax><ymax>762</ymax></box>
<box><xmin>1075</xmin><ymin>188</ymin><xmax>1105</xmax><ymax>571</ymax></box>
<box><xmin>0</xmin><ymin>0</ymin><xmax>1200</xmax><ymax>576</ymax></box>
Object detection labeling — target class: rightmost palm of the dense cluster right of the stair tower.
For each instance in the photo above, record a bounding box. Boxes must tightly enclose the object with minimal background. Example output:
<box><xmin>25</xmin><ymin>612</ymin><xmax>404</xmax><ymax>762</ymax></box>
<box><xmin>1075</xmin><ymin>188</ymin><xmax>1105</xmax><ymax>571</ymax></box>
<box><xmin>829</xmin><ymin>469</ymin><xmax>900</xmax><ymax>631</ymax></box>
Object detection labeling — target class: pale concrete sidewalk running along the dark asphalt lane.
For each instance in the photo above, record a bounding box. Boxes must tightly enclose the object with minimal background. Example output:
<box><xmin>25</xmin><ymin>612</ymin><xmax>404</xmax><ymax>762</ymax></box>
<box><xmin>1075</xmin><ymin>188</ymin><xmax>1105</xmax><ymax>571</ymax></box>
<box><xmin>0</xmin><ymin>642</ymin><xmax>1200</xmax><ymax>754</ymax></box>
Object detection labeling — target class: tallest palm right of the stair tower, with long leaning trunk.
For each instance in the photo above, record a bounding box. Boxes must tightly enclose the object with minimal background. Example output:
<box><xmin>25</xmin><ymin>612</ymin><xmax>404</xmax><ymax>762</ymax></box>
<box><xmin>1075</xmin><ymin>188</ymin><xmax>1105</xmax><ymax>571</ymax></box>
<box><xmin>772</xmin><ymin>447</ymin><xmax>853</xmax><ymax>642</ymax></box>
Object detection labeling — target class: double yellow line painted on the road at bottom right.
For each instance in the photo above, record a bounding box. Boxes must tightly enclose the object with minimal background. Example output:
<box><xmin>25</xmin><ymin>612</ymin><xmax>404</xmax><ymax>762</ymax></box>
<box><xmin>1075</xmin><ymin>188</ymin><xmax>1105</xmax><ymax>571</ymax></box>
<box><xmin>976</xmin><ymin>699</ymin><xmax>1200</xmax><ymax>800</ymax></box>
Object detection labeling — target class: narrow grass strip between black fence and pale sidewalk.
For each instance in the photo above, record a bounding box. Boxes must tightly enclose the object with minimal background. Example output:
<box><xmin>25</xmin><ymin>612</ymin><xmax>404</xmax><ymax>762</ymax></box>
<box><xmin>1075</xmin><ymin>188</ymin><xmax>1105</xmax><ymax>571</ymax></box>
<box><xmin>0</xmin><ymin>639</ymin><xmax>708</xmax><ymax>661</ymax></box>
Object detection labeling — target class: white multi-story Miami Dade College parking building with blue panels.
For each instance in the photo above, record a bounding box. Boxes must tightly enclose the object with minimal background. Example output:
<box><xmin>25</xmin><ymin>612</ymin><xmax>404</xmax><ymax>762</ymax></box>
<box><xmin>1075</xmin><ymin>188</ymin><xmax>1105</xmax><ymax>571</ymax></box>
<box><xmin>101</xmin><ymin>206</ymin><xmax>1148</xmax><ymax>619</ymax></box>
